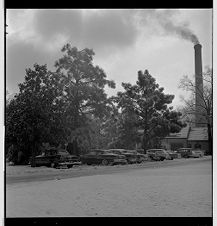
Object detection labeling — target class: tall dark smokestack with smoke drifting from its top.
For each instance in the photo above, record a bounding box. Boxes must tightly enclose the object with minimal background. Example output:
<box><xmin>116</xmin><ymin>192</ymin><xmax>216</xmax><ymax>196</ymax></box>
<box><xmin>194</xmin><ymin>43</ymin><xmax>206</xmax><ymax>127</ymax></box>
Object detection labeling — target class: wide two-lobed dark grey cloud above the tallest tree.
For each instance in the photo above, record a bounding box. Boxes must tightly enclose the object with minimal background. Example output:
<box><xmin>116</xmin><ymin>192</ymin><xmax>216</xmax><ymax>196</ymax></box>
<box><xmin>33</xmin><ymin>10</ymin><xmax>138</xmax><ymax>51</ymax></box>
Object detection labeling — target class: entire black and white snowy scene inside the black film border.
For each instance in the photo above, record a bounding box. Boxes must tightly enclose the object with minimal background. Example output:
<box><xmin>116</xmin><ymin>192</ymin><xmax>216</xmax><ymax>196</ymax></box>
<box><xmin>4</xmin><ymin>8</ymin><xmax>213</xmax><ymax>221</ymax></box>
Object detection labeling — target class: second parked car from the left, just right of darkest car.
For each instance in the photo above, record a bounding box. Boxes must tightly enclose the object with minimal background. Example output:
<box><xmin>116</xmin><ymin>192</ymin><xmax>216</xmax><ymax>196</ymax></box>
<box><xmin>80</xmin><ymin>149</ymin><xmax>127</xmax><ymax>165</ymax></box>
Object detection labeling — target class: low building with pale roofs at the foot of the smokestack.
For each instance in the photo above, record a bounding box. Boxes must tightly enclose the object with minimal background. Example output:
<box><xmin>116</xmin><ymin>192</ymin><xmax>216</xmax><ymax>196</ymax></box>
<box><xmin>162</xmin><ymin>126</ymin><xmax>208</xmax><ymax>151</ymax></box>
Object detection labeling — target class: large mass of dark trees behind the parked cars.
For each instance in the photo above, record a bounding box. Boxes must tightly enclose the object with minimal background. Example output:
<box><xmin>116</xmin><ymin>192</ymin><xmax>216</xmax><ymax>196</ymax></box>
<box><xmin>5</xmin><ymin>44</ymin><xmax>184</xmax><ymax>163</ymax></box>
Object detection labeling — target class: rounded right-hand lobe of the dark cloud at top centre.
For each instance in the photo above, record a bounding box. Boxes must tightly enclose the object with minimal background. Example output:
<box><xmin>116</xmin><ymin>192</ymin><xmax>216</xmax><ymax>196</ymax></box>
<box><xmin>84</xmin><ymin>11</ymin><xmax>138</xmax><ymax>48</ymax></box>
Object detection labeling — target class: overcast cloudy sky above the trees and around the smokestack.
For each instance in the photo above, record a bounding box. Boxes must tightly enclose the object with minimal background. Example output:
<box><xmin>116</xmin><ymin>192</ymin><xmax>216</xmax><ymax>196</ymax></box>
<box><xmin>6</xmin><ymin>9</ymin><xmax>212</xmax><ymax>109</ymax></box>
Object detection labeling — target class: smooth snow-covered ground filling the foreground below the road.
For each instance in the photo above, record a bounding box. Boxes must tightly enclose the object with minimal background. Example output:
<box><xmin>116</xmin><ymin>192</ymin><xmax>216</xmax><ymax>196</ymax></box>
<box><xmin>6</xmin><ymin>160</ymin><xmax>212</xmax><ymax>217</ymax></box>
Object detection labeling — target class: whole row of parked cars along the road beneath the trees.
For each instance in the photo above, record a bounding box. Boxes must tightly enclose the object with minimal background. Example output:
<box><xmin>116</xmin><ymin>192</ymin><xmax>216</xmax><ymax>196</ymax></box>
<box><xmin>30</xmin><ymin>148</ymin><xmax>204</xmax><ymax>168</ymax></box>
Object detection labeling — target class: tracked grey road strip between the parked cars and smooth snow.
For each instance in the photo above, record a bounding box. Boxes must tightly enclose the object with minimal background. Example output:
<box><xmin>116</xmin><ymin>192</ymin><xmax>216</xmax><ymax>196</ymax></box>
<box><xmin>6</xmin><ymin>156</ymin><xmax>210</xmax><ymax>184</ymax></box>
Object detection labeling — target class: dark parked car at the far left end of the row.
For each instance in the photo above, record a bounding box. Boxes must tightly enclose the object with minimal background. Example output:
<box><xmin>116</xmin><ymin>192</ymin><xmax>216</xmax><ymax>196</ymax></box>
<box><xmin>30</xmin><ymin>148</ymin><xmax>81</xmax><ymax>168</ymax></box>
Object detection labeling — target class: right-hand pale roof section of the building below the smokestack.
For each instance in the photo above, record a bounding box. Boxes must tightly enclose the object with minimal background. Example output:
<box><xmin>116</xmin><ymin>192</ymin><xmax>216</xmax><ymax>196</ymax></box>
<box><xmin>188</xmin><ymin>127</ymin><xmax>208</xmax><ymax>141</ymax></box>
